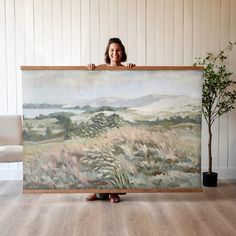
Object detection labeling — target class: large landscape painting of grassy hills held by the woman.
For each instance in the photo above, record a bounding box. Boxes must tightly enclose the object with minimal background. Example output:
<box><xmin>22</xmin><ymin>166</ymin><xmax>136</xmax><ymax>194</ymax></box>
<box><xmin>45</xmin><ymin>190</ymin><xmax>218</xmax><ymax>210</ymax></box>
<box><xmin>22</xmin><ymin>67</ymin><xmax>202</xmax><ymax>192</ymax></box>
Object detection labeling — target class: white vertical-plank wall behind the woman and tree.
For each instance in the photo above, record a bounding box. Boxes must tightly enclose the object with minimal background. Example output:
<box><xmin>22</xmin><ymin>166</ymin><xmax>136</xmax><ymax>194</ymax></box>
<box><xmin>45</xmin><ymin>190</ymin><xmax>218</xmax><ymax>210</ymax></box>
<box><xmin>0</xmin><ymin>0</ymin><xmax>236</xmax><ymax>178</ymax></box>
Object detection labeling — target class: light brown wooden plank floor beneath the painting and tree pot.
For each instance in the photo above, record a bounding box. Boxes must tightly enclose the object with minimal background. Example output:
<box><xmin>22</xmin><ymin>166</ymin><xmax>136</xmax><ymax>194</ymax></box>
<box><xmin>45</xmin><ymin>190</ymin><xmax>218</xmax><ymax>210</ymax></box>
<box><xmin>0</xmin><ymin>180</ymin><xmax>236</xmax><ymax>236</ymax></box>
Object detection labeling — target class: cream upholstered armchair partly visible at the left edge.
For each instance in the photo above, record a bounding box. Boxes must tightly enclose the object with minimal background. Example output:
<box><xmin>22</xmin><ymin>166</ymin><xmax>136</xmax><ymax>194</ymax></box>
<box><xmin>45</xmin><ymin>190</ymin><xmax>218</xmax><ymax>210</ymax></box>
<box><xmin>0</xmin><ymin>115</ymin><xmax>23</xmax><ymax>162</ymax></box>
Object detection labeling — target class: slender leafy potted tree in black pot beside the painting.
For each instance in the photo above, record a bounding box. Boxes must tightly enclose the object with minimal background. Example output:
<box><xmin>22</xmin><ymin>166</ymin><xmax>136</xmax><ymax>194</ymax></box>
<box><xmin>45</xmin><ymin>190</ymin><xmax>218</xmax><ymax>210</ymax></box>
<box><xmin>195</xmin><ymin>42</ymin><xmax>236</xmax><ymax>187</ymax></box>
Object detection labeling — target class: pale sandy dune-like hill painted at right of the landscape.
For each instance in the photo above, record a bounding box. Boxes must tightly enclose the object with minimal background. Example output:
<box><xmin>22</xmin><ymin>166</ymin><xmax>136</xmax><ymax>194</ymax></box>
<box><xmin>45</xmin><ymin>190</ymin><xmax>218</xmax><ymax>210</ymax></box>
<box><xmin>70</xmin><ymin>95</ymin><xmax>201</xmax><ymax>123</ymax></box>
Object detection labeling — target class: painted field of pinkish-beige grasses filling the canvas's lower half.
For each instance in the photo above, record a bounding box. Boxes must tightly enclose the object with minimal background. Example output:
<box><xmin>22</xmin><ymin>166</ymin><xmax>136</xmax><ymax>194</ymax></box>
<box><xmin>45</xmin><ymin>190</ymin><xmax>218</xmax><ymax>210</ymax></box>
<box><xmin>24</xmin><ymin>123</ymin><xmax>201</xmax><ymax>189</ymax></box>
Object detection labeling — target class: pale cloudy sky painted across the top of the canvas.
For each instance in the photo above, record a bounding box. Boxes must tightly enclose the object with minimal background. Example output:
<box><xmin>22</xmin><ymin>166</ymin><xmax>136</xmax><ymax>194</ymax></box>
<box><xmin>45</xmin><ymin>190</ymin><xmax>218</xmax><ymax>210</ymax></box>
<box><xmin>22</xmin><ymin>70</ymin><xmax>202</xmax><ymax>104</ymax></box>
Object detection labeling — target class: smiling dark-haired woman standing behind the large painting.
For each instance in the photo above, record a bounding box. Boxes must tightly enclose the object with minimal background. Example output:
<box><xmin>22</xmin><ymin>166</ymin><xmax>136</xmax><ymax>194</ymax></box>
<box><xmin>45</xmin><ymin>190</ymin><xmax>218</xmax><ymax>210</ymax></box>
<box><xmin>86</xmin><ymin>38</ymin><xmax>135</xmax><ymax>203</ymax></box>
